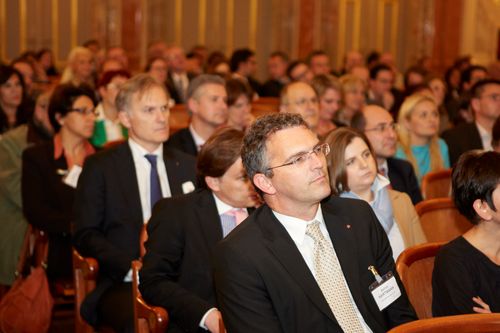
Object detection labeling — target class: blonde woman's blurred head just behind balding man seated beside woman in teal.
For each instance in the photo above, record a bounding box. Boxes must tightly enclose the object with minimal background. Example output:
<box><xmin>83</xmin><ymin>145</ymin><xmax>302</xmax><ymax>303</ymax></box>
<box><xmin>334</xmin><ymin>74</ymin><xmax>366</xmax><ymax>126</ymax></box>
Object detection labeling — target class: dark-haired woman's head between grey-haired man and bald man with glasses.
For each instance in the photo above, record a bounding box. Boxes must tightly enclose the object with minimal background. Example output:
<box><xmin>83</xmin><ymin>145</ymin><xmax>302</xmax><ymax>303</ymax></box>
<box><xmin>226</xmin><ymin>79</ymin><xmax>254</xmax><ymax>131</ymax></box>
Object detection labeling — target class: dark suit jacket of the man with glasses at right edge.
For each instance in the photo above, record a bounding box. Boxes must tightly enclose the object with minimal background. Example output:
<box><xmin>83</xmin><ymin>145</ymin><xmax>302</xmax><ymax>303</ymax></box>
<box><xmin>441</xmin><ymin>123</ymin><xmax>484</xmax><ymax>165</ymax></box>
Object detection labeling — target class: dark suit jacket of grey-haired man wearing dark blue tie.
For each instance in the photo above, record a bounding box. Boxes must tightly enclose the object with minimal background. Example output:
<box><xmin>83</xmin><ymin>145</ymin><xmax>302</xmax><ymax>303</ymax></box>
<box><xmin>74</xmin><ymin>142</ymin><xmax>195</xmax><ymax>324</ymax></box>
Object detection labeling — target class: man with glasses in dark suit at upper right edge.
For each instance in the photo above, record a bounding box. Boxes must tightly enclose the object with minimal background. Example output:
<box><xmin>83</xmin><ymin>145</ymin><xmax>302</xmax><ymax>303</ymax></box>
<box><xmin>442</xmin><ymin>79</ymin><xmax>500</xmax><ymax>165</ymax></box>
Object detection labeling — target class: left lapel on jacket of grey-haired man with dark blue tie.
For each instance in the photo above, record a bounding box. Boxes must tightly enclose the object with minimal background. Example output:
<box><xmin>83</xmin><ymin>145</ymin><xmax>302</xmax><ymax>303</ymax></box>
<box><xmin>114</xmin><ymin>142</ymin><xmax>143</xmax><ymax>221</ymax></box>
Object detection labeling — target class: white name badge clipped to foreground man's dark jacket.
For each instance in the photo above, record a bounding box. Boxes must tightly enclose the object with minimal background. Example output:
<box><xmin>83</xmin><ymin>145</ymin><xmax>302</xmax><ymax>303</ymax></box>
<box><xmin>368</xmin><ymin>266</ymin><xmax>401</xmax><ymax>311</ymax></box>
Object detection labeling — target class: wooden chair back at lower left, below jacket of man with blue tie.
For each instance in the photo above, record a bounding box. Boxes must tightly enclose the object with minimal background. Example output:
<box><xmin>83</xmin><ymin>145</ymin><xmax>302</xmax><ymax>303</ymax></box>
<box><xmin>73</xmin><ymin>249</ymin><xmax>99</xmax><ymax>333</ymax></box>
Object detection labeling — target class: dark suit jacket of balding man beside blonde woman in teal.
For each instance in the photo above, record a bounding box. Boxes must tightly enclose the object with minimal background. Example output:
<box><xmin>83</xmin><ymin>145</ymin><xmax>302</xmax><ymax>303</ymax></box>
<box><xmin>387</xmin><ymin>157</ymin><xmax>423</xmax><ymax>205</ymax></box>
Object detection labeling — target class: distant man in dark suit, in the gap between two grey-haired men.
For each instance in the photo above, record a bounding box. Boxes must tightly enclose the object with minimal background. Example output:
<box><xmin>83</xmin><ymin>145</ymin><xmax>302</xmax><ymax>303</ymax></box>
<box><xmin>166</xmin><ymin>46</ymin><xmax>194</xmax><ymax>104</ymax></box>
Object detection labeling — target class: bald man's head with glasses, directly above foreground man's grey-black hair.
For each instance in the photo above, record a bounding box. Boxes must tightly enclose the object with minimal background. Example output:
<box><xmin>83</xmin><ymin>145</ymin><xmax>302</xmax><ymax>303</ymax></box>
<box><xmin>280</xmin><ymin>82</ymin><xmax>319</xmax><ymax>132</ymax></box>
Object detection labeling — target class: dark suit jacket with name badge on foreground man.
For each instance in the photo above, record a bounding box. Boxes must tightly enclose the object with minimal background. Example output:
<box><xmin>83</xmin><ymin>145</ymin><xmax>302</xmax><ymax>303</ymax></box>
<box><xmin>215</xmin><ymin>198</ymin><xmax>416</xmax><ymax>333</ymax></box>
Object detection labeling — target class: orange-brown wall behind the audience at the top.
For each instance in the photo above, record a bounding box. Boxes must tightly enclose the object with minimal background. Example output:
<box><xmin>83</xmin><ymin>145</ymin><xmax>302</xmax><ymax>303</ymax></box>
<box><xmin>0</xmin><ymin>0</ymin><xmax>500</xmax><ymax>78</ymax></box>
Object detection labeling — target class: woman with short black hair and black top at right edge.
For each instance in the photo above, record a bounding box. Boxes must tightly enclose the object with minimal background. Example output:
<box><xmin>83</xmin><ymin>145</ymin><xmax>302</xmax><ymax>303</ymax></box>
<box><xmin>432</xmin><ymin>151</ymin><xmax>500</xmax><ymax>316</ymax></box>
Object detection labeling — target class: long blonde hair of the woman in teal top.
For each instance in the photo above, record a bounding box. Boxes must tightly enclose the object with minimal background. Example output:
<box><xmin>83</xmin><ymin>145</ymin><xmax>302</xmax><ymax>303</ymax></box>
<box><xmin>398</xmin><ymin>93</ymin><xmax>444</xmax><ymax>176</ymax></box>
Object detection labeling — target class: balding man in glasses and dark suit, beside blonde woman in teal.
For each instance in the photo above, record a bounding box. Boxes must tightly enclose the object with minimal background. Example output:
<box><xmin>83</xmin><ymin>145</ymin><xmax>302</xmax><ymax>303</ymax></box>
<box><xmin>351</xmin><ymin>105</ymin><xmax>422</xmax><ymax>205</ymax></box>
